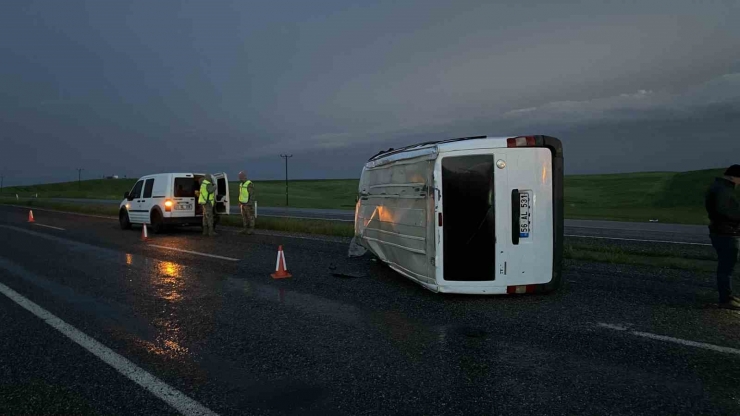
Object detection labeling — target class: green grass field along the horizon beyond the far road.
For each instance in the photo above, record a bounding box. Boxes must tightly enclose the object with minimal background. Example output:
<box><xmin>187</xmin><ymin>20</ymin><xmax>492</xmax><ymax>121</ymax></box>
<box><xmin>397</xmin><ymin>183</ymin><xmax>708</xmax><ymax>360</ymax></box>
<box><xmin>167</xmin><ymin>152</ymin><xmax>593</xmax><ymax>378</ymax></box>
<box><xmin>3</xmin><ymin>169</ymin><xmax>722</xmax><ymax>224</ymax></box>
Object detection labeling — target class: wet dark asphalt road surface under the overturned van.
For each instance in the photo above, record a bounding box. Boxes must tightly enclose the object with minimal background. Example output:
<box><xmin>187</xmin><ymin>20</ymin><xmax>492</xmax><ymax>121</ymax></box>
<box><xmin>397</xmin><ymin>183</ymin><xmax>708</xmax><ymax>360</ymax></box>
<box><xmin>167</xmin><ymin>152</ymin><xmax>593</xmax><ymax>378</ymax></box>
<box><xmin>0</xmin><ymin>207</ymin><xmax>740</xmax><ymax>415</ymax></box>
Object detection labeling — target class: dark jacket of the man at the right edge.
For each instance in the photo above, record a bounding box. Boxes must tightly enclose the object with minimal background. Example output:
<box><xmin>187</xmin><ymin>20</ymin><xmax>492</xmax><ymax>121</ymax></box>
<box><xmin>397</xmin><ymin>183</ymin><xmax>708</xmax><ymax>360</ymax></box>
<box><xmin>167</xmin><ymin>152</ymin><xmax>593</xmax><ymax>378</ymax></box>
<box><xmin>705</xmin><ymin>178</ymin><xmax>740</xmax><ymax>236</ymax></box>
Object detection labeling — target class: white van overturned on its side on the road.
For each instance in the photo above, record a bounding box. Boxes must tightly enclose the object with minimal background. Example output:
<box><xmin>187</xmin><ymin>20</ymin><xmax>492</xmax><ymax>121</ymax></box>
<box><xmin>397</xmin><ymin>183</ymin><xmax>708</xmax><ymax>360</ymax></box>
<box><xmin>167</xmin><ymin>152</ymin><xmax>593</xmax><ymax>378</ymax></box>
<box><xmin>350</xmin><ymin>136</ymin><xmax>563</xmax><ymax>294</ymax></box>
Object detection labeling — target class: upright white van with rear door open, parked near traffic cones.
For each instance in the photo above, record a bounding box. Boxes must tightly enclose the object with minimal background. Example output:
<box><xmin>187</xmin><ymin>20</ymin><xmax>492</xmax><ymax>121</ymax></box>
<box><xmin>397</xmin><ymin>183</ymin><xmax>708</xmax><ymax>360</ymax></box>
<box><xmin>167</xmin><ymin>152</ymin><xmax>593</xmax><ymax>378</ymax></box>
<box><xmin>118</xmin><ymin>173</ymin><xmax>230</xmax><ymax>233</ymax></box>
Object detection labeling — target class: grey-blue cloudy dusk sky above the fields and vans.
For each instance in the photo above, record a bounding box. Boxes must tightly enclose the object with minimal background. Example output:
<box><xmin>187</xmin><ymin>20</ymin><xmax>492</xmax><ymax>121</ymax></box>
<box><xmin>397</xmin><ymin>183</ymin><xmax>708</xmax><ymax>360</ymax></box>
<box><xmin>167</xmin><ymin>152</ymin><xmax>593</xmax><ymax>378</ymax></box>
<box><xmin>0</xmin><ymin>0</ymin><xmax>740</xmax><ymax>186</ymax></box>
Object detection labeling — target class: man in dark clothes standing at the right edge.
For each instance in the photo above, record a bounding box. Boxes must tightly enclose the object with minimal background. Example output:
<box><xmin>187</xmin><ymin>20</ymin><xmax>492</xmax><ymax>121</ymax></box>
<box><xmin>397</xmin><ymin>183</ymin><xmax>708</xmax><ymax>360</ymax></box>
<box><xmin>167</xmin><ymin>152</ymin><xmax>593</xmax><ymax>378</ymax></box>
<box><xmin>705</xmin><ymin>165</ymin><xmax>740</xmax><ymax>310</ymax></box>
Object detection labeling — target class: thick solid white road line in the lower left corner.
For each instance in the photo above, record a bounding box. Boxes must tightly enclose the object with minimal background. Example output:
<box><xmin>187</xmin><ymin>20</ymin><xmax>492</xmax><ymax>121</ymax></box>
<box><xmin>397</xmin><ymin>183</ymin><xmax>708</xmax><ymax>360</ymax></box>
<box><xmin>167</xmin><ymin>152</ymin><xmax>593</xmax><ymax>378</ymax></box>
<box><xmin>0</xmin><ymin>283</ymin><xmax>216</xmax><ymax>416</ymax></box>
